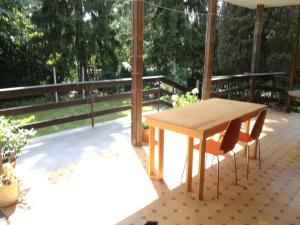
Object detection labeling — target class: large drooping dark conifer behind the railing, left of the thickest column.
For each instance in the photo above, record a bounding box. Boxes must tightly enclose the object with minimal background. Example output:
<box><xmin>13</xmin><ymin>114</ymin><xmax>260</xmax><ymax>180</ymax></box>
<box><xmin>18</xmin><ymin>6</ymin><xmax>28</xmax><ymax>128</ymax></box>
<box><xmin>33</xmin><ymin>0</ymin><xmax>118</xmax><ymax>80</ymax></box>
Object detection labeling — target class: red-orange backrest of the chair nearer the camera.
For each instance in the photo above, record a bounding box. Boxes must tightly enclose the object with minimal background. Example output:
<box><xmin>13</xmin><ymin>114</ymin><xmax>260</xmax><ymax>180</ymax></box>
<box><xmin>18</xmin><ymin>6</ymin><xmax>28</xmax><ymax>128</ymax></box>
<box><xmin>221</xmin><ymin>118</ymin><xmax>242</xmax><ymax>153</ymax></box>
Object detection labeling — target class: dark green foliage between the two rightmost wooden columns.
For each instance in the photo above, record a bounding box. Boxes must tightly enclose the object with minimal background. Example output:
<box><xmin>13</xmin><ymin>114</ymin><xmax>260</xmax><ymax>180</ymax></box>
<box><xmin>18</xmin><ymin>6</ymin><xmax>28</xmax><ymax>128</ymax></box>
<box><xmin>260</xmin><ymin>7</ymin><xmax>298</xmax><ymax>72</ymax></box>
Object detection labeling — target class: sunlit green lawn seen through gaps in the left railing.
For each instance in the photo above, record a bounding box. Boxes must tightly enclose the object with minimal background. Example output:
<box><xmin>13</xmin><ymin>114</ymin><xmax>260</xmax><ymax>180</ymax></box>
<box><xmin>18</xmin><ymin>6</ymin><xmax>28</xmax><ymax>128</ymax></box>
<box><xmin>13</xmin><ymin>99</ymin><xmax>155</xmax><ymax>136</ymax></box>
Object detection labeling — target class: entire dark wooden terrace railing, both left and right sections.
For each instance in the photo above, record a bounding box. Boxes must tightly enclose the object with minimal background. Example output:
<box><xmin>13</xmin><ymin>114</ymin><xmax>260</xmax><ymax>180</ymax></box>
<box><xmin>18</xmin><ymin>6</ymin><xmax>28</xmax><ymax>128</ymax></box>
<box><xmin>0</xmin><ymin>73</ymin><xmax>288</xmax><ymax>128</ymax></box>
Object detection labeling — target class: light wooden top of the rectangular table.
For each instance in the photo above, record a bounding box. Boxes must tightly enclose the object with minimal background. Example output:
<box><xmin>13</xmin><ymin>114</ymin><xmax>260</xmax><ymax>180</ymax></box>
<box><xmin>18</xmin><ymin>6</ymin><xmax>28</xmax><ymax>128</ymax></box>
<box><xmin>145</xmin><ymin>98</ymin><xmax>266</xmax><ymax>137</ymax></box>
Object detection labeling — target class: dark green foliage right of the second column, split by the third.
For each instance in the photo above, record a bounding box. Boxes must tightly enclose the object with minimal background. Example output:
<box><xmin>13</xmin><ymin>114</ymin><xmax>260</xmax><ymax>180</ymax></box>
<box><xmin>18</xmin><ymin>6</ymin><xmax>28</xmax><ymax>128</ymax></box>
<box><xmin>217</xmin><ymin>3</ymin><xmax>298</xmax><ymax>74</ymax></box>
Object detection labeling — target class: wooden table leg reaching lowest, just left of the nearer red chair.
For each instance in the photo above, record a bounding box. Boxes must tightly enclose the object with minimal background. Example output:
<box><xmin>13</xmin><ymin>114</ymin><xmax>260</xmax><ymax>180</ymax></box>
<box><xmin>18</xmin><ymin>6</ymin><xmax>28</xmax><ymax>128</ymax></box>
<box><xmin>197</xmin><ymin>138</ymin><xmax>206</xmax><ymax>200</ymax></box>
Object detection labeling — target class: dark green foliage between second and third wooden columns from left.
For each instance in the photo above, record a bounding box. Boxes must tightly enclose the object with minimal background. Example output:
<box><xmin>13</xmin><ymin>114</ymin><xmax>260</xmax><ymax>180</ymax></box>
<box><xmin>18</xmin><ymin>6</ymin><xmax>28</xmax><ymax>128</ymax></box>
<box><xmin>216</xmin><ymin>2</ymin><xmax>255</xmax><ymax>74</ymax></box>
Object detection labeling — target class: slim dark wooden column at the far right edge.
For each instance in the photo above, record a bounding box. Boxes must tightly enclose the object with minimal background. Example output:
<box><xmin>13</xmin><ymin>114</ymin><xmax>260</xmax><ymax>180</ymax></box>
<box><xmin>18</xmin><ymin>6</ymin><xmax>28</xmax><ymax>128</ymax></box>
<box><xmin>286</xmin><ymin>9</ymin><xmax>300</xmax><ymax>112</ymax></box>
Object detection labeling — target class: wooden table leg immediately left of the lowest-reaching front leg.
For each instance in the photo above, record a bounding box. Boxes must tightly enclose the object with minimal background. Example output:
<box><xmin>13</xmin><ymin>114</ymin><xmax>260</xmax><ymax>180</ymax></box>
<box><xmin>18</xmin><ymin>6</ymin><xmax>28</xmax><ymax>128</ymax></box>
<box><xmin>186</xmin><ymin>137</ymin><xmax>194</xmax><ymax>192</ymax></box>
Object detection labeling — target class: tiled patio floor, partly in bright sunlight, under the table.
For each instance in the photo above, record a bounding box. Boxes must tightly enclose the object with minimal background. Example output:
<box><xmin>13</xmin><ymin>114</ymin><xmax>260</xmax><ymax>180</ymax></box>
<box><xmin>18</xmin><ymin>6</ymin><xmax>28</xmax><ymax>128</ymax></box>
<box><xmin>1</xmin><ymin>110</ymin><xmax>300</xmax><ymax>225</ymax></box>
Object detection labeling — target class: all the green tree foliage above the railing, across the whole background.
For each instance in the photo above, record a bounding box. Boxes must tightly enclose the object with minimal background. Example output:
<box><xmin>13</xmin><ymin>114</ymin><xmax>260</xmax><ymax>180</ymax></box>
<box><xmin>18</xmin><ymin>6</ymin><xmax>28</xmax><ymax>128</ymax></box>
<box><xmin>0</xmin><ymin>0</ymin><xmax>298</xmax><ymax>87</ymax></box>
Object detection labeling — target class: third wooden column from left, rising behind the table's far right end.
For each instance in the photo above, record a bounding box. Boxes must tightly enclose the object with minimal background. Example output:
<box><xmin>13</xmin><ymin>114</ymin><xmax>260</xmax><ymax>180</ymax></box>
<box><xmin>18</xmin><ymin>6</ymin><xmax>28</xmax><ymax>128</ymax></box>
<box><xmin>249</xmin><ymin>5</ymin><xmax>264</xmax><ymax>102</ymax></box>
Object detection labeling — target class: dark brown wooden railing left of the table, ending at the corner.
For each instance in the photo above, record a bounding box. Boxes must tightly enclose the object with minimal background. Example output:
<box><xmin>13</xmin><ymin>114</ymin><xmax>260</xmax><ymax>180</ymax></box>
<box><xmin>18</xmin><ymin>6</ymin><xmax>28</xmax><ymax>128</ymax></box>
<box><xmin>0</xmin><ymin>76</ymin><xmax>188</xmax><ymax>128</ymax></box>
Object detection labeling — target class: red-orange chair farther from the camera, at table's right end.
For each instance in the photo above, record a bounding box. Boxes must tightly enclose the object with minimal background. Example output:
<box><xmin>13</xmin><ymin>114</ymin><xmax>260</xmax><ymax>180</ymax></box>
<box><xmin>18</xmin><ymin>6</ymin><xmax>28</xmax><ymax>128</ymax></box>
<box><xmin>239</xmin><ymin>110</ymin><xmax>267</xmax><ymax>179</ymax></box>
